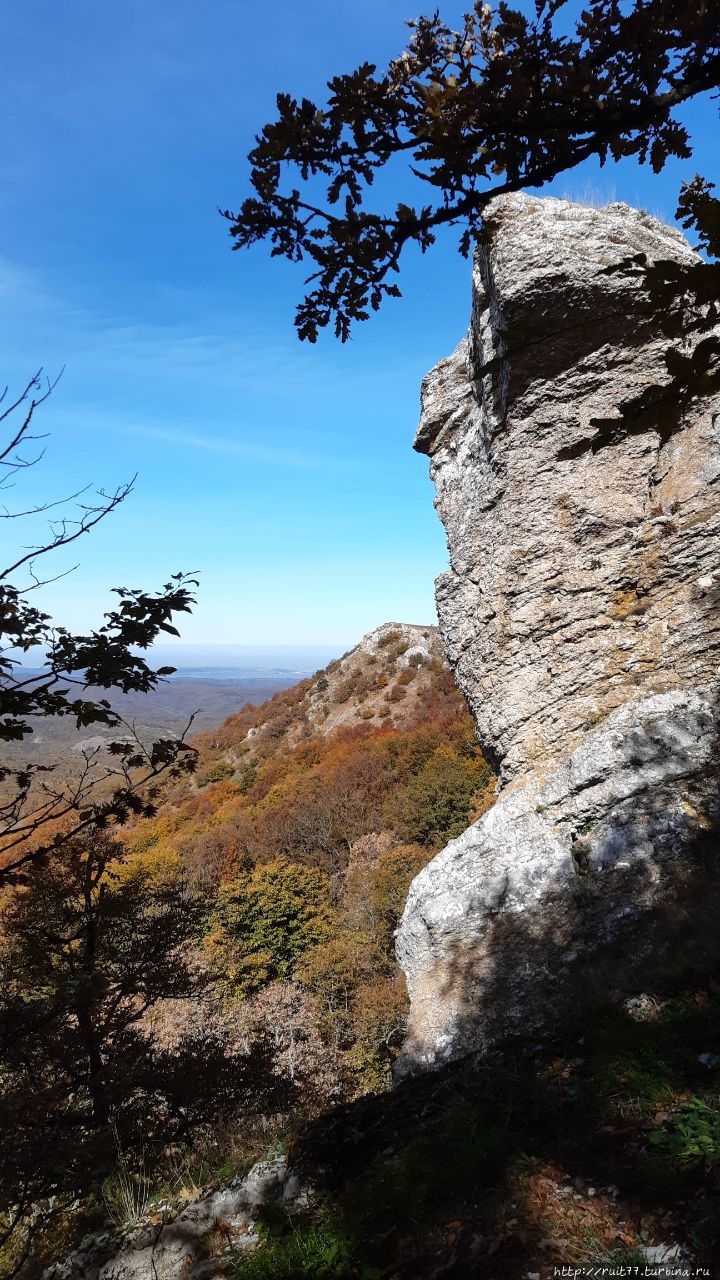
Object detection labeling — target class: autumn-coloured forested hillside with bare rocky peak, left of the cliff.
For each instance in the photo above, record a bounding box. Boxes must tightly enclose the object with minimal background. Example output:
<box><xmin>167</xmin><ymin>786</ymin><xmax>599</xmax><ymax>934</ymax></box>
<box><xmin>0</xmin><ymin>625</ymin><xmax>493</xmax><ymax>1275</ymax></box>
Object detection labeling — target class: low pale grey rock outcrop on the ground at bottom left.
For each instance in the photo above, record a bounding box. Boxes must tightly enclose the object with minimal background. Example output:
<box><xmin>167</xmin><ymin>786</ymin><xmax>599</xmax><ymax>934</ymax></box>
<box><xmin>42</xmin><ymin>1157</ymin><xmax>307</xmax><ymax>1280</ymax></box>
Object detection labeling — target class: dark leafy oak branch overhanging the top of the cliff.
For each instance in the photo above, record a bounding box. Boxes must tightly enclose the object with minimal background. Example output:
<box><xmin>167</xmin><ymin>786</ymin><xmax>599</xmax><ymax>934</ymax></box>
<box><xmin>224</xmin><ymin>0</ymin><xmax>720</xmax><ymax>342</ymax></box>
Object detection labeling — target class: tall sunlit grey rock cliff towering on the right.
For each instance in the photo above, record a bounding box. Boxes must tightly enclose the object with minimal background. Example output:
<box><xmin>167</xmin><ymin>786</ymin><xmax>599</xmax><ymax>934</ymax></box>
<box><xmin>397</xmin><ymin>196</ymin><xmax>720</xmax><ymax>1069</ymax></box>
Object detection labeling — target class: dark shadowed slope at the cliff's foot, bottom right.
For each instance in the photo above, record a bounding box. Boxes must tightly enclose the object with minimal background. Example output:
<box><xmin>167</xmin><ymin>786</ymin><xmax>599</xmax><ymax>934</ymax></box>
<box><xmin>286</xmin><ymin>808</ymin><xmax>720</xmax><ymax>1280</ymax></box>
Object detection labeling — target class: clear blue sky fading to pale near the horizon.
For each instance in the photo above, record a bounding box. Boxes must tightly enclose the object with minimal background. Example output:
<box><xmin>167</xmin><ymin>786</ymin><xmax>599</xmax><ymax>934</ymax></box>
<box><xmin>0</xmin><ymin>0</ymin><xmax>717</xmax><ymax>648</ymax></box>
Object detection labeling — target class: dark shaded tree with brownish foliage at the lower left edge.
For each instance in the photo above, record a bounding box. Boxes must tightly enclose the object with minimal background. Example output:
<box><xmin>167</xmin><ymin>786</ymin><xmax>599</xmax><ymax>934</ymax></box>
<box><xmin>0</xmin><ymin>831</ymin><xmax>292</xmax><ymax>1276</ymax></box>
